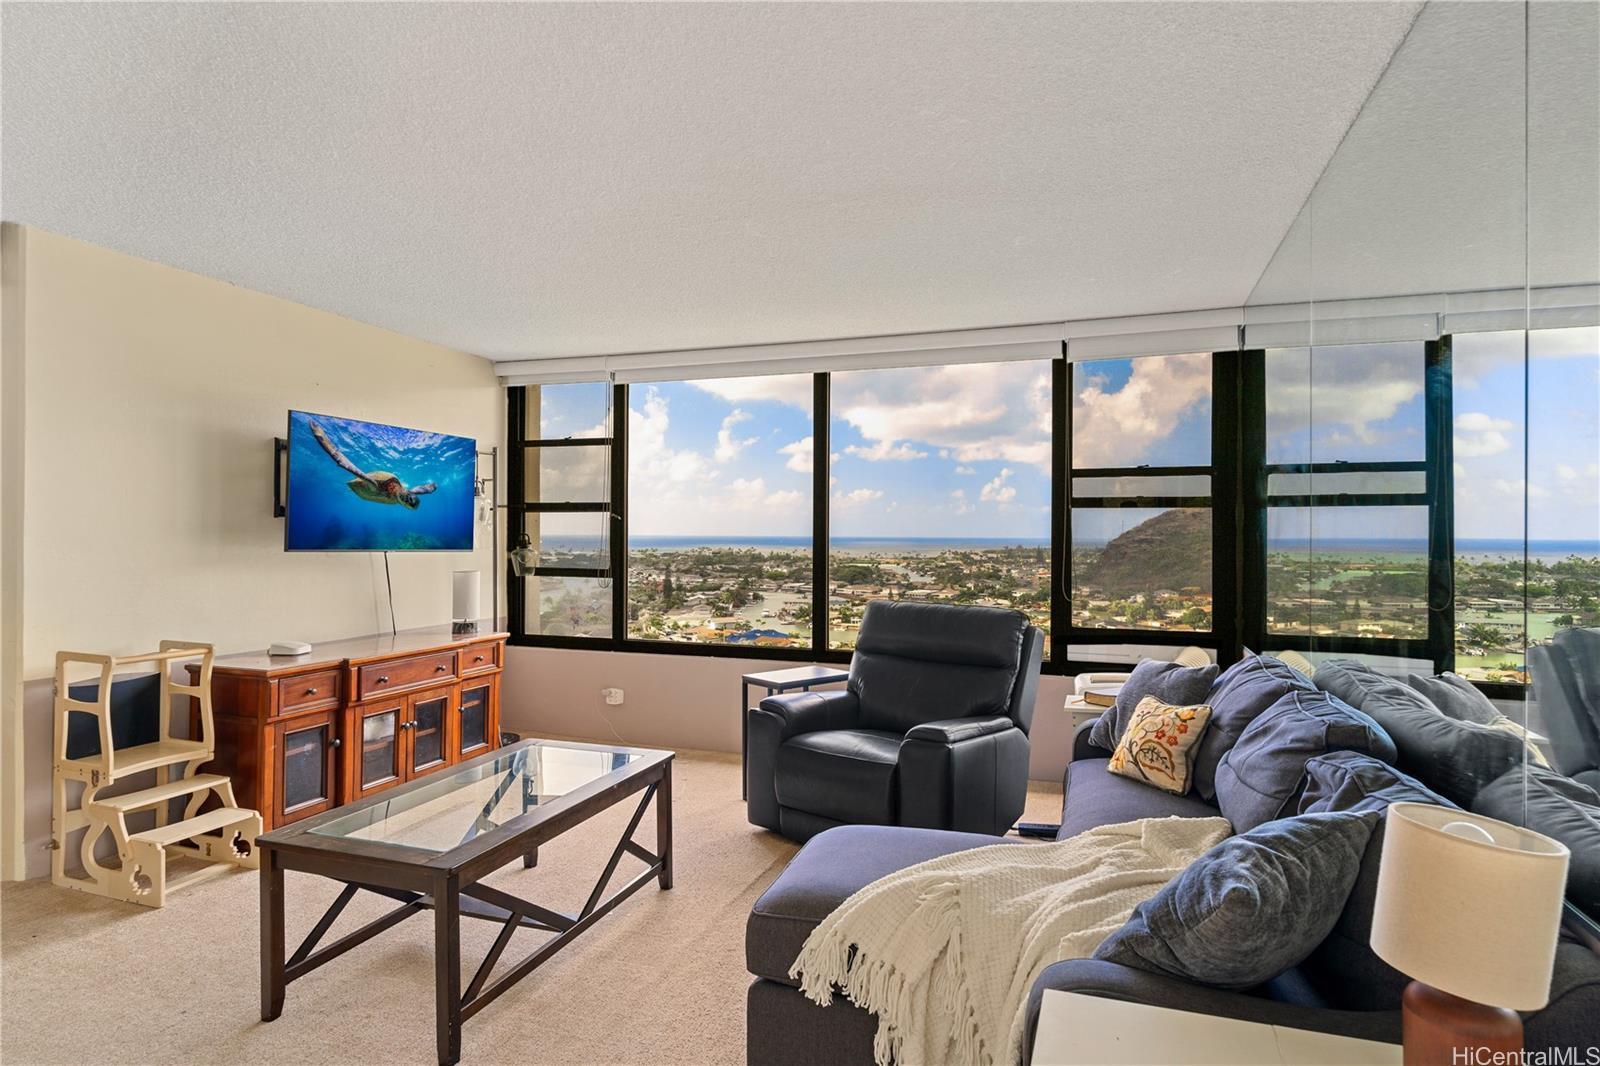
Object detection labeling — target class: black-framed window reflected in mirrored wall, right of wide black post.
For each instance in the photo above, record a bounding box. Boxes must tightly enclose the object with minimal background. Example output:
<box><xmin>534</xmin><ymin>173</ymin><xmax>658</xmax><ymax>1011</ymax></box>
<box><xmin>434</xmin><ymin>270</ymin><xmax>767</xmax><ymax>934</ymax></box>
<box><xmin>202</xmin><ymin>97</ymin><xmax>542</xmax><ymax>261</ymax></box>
<box><xmin>1262</xmin><ymin>339</ymin><xmax>1453</xmax><ymax>671</ymax></box>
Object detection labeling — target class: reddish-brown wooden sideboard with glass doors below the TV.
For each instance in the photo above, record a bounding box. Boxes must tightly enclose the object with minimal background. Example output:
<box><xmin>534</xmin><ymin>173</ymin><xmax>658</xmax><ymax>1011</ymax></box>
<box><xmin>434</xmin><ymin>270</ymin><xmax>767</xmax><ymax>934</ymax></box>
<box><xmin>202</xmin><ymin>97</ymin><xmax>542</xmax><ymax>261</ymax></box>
<box><xmin>190</xmin><ymin>626</ymin><xmax>507</xmax><ymax>829</ymax></box>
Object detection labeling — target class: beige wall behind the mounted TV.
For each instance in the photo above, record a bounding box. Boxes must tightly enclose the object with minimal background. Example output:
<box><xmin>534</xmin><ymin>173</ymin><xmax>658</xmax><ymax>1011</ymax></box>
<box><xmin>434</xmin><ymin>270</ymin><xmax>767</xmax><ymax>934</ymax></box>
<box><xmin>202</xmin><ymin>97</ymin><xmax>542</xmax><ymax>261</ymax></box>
<box><xmin>0</xmin><ymin>227</ymin><xmax>504</xmax><ymax>871</ymax></box>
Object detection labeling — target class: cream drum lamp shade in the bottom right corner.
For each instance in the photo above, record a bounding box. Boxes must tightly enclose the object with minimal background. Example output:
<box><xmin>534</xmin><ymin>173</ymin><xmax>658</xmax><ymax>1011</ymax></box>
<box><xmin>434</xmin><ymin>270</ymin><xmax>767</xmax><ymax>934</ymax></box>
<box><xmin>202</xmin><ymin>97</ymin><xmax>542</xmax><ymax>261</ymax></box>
<box><xmin>1371</xmin><ymin>804</ymin><xmax>1568</xmax><ymax>1010</ymax></box>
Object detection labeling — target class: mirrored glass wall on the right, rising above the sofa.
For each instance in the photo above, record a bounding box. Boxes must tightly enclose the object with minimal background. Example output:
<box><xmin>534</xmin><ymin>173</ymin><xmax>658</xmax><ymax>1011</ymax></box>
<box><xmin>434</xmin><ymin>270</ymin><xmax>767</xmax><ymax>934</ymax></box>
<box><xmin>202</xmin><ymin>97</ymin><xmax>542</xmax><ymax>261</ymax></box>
<box><xmin>1245</xmin><ymin>3</ymin><xmax>1600</xmax><ymax>936</ymax></box>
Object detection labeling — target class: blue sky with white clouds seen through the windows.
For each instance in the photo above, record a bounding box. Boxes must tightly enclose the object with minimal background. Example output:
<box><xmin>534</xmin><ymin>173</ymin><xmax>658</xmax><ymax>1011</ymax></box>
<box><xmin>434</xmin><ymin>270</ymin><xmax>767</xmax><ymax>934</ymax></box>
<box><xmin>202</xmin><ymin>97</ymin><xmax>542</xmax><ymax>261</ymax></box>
<box><xmin>542</xmin><ymin>330</ymin><xmax>1600</xmax><ymax>541</ymax></box>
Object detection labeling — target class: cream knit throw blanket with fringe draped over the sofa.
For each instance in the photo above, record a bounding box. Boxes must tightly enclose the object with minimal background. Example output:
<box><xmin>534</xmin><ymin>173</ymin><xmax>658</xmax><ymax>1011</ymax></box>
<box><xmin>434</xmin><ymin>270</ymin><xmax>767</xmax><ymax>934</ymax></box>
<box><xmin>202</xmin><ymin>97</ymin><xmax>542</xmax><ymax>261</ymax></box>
<box><xmin>789</xmin><ymin>818</ymin><xmax>1230</xmax><ymax>1066</ymax></box>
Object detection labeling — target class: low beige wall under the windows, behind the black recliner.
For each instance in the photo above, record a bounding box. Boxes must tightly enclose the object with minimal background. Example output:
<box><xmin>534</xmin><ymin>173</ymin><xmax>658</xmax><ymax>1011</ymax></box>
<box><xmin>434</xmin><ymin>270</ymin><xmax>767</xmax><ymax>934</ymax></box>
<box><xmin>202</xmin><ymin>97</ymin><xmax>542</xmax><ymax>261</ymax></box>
<box><xmin>501</xmin><ymin>648</ymin><xmax>1072</xmax><ymax>783</ymax></box>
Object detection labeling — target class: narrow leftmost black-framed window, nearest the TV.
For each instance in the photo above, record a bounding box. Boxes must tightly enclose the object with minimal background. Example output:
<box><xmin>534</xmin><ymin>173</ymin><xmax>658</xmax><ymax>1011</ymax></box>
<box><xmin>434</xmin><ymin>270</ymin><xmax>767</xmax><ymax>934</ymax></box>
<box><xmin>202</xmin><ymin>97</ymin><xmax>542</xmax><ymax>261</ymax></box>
<box><xmin>509</xmin><ymin>381</ymin><xmax>614</xmax><ymax>640</ymax></box>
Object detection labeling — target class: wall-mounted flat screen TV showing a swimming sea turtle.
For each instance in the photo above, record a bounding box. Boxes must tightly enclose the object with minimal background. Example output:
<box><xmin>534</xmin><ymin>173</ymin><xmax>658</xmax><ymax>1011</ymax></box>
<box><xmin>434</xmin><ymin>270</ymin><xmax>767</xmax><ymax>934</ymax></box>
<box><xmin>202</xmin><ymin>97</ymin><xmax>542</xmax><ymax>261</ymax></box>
<box><xmin>283</xmin><ymin>411</ymin><xmax>477</xmax><ymax>552</ymax></box>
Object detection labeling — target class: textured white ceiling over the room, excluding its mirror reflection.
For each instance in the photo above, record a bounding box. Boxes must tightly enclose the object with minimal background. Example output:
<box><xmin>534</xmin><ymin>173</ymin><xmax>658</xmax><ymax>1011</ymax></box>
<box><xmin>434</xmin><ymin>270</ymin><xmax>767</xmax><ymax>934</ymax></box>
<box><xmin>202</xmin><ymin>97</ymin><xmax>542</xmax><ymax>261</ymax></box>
<box><xmin>0</xmin><ymin>2</ymin><xmax>1418</xmax><ymax>359</ymax></box>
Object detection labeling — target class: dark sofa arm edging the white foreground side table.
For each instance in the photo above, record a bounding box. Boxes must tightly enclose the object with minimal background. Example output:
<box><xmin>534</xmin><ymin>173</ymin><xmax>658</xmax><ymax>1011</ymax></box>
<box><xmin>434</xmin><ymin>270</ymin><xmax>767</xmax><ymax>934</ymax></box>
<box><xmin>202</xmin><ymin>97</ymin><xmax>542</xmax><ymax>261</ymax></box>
<box><xmin>1022</xmin><ymin>959</ymin><xmax>1400</xmax><ymax>1063</ymax></box>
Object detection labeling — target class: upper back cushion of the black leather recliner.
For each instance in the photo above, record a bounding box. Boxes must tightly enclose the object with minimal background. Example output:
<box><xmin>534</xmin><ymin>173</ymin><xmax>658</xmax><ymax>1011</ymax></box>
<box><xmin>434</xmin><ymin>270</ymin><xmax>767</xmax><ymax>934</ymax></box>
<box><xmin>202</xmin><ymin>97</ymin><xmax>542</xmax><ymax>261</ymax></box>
<box><xmin>850</xmin><ymin>600</ymin><xmax>1027</xmax><ymax>736</ymax></box>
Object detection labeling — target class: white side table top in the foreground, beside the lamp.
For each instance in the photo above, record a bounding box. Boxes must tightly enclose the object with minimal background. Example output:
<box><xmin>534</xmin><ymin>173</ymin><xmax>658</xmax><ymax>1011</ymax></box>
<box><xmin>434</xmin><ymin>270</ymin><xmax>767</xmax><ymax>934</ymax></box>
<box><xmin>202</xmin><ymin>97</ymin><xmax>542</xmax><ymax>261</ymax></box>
<box><xmin>1032</xmin><ymin>989</ymin><xmax>1402</xmax><ymax>1066</ymax></box>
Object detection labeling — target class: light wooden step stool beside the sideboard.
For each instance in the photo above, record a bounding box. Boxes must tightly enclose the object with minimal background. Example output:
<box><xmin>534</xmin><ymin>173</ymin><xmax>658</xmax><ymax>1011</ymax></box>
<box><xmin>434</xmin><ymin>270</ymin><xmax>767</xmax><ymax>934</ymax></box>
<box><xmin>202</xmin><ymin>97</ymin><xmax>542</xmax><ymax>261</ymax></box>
<box><xmin>50</xmin><ymin>640</ymin><xmax>261</xmax><ymax>908</ymax></box>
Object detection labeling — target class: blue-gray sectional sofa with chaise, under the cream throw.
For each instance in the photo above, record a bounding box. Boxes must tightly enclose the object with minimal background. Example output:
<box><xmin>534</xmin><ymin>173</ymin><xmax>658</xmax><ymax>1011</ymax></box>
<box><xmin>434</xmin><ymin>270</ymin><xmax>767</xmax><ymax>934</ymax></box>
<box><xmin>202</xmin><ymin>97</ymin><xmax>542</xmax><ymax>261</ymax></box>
<box><xmin>746</xmin><ymin>656</ymin><xmax>1600</xmax><ymax>1066</ymax></box>
